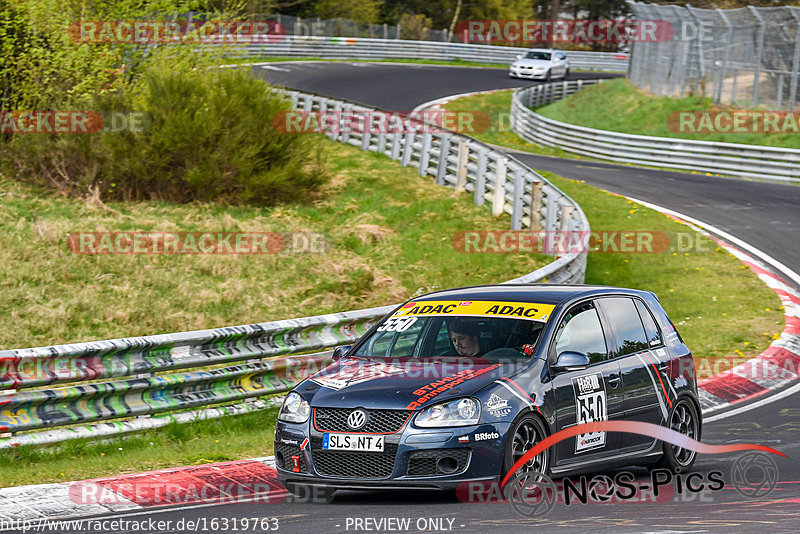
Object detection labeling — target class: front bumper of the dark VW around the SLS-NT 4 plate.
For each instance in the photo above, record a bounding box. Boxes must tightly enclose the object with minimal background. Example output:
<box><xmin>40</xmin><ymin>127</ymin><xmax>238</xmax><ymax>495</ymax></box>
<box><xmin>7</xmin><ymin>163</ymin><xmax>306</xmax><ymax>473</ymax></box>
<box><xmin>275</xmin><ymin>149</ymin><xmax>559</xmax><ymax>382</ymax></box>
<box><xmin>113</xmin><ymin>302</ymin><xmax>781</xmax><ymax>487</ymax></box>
<box><xmin>275</xmin><ymin>421</ymin><xmax>510</xmax><ymax>489</ymax></box>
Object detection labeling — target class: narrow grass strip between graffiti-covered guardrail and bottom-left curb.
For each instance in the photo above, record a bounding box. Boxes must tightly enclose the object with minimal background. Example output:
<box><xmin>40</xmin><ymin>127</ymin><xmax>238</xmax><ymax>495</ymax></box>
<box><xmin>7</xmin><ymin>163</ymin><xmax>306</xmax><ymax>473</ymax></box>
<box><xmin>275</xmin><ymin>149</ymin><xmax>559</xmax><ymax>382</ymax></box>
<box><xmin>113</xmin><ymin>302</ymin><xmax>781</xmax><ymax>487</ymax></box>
<box><xmin>0</xmin><ymin>408</ymin><xmax>278</xmax><ymax>487</ymax></box>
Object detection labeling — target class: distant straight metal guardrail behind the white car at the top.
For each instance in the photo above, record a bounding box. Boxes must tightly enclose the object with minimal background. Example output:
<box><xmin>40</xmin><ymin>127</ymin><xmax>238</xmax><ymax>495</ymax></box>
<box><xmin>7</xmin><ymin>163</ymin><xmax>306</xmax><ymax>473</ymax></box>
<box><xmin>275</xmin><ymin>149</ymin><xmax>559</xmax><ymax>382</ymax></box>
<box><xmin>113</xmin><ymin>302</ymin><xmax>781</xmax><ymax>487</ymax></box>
<box><xmin>219</xmin><ymin>35</ymin><xmax>628</xmax><ymax>72</ymax></box>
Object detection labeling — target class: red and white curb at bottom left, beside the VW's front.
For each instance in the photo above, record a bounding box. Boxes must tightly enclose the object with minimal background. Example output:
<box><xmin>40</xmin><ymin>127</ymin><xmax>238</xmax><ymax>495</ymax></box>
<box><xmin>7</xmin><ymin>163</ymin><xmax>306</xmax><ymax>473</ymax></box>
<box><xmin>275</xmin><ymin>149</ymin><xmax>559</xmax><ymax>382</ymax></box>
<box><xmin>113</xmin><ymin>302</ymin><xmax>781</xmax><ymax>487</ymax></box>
<box><xmin>0</xmin><ymin>456</ymin><xmax>286</xmax><ymax>526</ymax></box>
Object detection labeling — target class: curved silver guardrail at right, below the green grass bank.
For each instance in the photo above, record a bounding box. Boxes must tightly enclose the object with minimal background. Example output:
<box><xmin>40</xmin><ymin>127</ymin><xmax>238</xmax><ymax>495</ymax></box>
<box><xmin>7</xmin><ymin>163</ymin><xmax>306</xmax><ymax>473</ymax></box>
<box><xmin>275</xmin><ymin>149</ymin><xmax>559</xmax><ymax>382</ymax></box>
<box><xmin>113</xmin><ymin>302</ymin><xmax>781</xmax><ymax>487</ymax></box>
<box><xmin>511</xmin><ymin>80</ymin><xmax>800</xmax><ymax>182</ymax></box>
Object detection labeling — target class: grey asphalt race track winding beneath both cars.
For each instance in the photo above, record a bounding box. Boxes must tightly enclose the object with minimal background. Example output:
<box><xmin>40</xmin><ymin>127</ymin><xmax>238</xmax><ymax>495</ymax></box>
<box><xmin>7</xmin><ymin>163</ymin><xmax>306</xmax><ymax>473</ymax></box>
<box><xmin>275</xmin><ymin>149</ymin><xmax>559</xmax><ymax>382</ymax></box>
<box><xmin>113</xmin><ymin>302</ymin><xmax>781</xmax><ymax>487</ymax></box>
<box><xmin>59</xmin><ymin>62</ymin><xmax>800</xmax><ymax>533</ymax></box>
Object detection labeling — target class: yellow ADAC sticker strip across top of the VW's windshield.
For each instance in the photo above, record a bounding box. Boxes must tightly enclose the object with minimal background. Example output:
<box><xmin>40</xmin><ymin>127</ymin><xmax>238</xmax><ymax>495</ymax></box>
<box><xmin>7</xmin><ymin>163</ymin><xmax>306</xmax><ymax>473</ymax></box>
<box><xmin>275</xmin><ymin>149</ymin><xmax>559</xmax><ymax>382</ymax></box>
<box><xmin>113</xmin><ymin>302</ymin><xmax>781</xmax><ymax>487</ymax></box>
<box><xmin>392</xmin><ymin>300</ymin><xmax>555</xmax><ymax>322</ymax></box>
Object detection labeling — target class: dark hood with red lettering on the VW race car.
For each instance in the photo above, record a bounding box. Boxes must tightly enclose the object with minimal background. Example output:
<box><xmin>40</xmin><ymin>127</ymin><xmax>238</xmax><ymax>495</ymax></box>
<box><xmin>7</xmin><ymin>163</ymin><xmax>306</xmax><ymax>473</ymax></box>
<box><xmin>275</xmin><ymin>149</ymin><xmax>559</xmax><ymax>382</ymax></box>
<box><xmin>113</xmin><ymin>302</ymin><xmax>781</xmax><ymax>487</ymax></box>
<box><xmin>296</xmin><ymin>358</ymin><xmax>519</xmax><ymax>410</ymax></box>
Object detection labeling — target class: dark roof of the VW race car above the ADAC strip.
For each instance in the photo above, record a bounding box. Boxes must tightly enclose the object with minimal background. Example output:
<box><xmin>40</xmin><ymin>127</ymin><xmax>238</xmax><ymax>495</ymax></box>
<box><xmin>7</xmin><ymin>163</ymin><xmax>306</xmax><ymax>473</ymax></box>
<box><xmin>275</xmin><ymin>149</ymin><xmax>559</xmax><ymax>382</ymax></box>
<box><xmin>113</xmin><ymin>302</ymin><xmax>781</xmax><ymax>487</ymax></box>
<box><xmin>411</xmin><ymin>284</ymin><xmax>649</xmax><ymax>305</ymax></box>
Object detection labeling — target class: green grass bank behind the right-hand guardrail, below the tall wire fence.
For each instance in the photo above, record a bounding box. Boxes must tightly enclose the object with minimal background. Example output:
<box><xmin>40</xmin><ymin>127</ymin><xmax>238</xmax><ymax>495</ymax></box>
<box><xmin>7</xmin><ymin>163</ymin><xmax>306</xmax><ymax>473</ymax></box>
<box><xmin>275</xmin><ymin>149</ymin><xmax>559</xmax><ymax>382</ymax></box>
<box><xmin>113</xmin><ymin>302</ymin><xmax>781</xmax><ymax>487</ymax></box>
<box><xmin>536</xmin><ymin>78</ymin><xmax>800</xmax><ymax>148</ymax></box>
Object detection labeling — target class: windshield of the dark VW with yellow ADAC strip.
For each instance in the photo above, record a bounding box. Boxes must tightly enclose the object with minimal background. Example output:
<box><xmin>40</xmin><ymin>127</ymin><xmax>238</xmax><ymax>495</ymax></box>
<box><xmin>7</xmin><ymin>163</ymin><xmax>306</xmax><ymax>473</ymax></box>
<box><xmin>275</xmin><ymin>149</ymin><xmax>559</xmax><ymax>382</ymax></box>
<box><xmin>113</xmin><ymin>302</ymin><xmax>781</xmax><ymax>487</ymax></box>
<box><xmin>355</xmin><ymin>301</ymin><xmax>553</xmax><ymax>360</ymax></box>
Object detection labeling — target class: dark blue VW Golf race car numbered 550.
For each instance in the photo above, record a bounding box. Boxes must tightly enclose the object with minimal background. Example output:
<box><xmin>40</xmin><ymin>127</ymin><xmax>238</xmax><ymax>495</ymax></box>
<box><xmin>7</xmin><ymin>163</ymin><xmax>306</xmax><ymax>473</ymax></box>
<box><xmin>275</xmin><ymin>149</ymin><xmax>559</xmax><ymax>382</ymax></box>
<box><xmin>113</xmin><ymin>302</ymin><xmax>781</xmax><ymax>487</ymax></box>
<box><xmin>275</xmin><ymin>284</ymin><xmax>702</xmax><ymax>494</ymax></box>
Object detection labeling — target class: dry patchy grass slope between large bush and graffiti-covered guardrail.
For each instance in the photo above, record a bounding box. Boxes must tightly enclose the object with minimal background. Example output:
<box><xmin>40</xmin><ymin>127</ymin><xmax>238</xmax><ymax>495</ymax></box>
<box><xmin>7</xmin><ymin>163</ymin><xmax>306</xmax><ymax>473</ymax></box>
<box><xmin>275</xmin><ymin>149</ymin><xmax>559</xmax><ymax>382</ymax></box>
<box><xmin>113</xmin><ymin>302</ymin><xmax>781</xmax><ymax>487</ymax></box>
<box><xmin>0</xmin><ymin>138</ymin><xmax>549</xmax><ymax>348</ymax></box>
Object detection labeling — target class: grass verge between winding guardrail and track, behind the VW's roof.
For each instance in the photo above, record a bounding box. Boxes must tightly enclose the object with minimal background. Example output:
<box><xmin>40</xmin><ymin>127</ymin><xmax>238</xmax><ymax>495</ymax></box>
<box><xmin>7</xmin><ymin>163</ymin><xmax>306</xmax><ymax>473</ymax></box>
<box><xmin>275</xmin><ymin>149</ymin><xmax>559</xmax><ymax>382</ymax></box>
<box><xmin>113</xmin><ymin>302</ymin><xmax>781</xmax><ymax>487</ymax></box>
<box><xmin>440</xmin><ymin>93</ymin><xmax>783</xmax><ymax>364</ymax></box>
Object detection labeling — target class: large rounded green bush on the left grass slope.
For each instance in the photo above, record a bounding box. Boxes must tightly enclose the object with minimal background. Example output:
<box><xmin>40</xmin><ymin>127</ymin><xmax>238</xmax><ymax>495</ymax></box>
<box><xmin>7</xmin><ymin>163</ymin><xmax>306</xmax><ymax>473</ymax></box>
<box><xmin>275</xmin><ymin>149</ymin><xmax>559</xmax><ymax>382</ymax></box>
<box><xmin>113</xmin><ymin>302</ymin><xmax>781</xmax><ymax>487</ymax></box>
<box><xmin>0</xmin><ymin>58</ymin><xmax>323</xmax><ymax>205</ymax></box>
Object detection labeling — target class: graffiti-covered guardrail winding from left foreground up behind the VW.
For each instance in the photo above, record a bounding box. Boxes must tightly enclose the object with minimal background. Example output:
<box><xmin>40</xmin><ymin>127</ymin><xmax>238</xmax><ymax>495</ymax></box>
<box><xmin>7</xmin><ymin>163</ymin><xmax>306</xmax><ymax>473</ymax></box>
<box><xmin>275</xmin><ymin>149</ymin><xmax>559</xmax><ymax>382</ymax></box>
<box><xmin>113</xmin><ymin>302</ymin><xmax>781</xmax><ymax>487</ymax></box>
<box><xmin>0</xmin><ymin>91</ymin><xmax>590</xmax><ymax>448</ymax></box>
